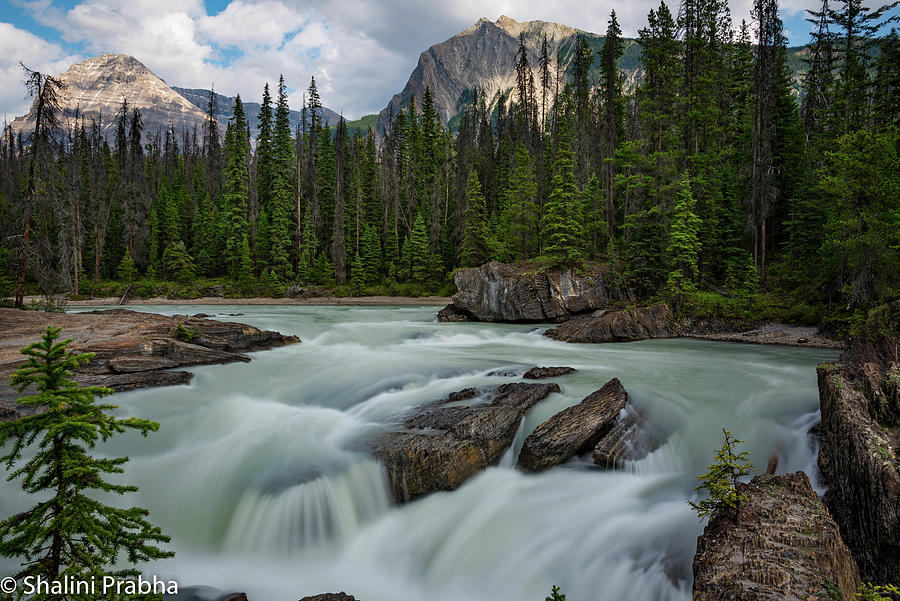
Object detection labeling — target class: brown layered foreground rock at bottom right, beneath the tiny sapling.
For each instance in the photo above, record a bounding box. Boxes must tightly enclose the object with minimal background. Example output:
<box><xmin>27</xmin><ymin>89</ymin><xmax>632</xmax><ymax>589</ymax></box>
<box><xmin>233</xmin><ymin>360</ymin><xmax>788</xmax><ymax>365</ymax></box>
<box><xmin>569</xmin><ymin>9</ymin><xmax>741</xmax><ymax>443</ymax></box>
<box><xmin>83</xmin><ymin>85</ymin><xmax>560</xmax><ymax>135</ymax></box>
<box><xmin>693</xmin><ymin>472</ymin><xmax>860</xmax><ymax>601</ymax></box>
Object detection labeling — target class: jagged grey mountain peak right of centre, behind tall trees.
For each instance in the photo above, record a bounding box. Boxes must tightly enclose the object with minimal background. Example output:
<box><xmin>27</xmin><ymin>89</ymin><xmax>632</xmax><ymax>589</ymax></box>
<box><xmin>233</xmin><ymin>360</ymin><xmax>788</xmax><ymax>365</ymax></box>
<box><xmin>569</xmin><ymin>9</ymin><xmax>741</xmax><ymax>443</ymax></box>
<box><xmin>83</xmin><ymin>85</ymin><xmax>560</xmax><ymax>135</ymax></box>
<box><xmin>376</xmin><ymin>16</ymin><xmax>805</xmax><ymax>135</ymax></box>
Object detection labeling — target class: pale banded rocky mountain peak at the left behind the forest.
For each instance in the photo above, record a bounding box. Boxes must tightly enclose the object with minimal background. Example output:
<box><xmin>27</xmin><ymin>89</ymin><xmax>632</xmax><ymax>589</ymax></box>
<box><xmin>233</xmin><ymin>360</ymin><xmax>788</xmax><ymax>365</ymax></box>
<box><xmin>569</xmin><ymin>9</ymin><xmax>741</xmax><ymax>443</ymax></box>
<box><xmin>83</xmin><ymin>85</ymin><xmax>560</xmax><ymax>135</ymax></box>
<box><xmin>10</xmin><ymin>54</ymin><xmax>206</xmax><ymax>142</ymax></box>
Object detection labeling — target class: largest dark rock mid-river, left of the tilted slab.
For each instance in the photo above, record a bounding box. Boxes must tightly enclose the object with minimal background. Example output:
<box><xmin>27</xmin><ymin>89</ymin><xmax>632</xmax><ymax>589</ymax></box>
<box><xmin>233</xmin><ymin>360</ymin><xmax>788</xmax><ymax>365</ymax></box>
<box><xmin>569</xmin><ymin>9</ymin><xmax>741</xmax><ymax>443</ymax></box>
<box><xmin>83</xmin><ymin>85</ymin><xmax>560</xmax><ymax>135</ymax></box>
<box><xmin>373</xmin><ymin>383</ymin><xmax>559</xmax><ymax>502</ymax></box>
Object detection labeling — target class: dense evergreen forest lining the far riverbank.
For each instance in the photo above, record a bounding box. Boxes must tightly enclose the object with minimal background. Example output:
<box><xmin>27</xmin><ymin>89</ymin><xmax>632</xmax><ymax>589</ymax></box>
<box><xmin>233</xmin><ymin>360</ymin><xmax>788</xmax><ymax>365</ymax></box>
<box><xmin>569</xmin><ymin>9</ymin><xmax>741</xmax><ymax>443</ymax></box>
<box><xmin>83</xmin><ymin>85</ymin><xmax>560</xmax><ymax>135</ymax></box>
<box><xmin>0</xmin><ymin>0</ymin><xmax>900</xmax><ymax>322</ymax></box>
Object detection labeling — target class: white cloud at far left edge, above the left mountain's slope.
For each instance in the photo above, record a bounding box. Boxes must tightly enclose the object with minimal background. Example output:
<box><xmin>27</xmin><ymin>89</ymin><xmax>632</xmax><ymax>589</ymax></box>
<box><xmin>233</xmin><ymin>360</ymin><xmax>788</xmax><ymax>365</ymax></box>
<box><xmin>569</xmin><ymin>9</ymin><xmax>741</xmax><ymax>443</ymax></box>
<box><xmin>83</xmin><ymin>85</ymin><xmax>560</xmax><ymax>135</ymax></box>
<box><xmin>0</xmin><ymin>23</ymin><xmax>78</xmax><ymax>121</ymax></box>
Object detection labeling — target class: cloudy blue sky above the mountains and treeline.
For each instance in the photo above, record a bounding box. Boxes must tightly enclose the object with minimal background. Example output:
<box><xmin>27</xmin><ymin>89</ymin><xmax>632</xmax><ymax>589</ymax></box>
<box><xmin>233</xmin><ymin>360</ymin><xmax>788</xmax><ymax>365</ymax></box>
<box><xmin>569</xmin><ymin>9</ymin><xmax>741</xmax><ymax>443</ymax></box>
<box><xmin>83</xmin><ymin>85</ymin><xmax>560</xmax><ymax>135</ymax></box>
<box><xmin>0</xmin><ymin>0</ymin><xmax>884</xmax><ymax>120</ymax></box>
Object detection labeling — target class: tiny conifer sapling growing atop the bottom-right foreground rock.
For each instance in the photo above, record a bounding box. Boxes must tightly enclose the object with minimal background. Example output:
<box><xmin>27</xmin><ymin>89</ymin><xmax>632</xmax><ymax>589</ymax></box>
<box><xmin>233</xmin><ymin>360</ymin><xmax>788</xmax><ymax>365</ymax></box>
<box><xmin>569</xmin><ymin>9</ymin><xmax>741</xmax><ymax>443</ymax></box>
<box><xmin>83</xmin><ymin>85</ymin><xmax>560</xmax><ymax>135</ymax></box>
<box><xmin>691</xmin><ymin>428</ymin><xmax>755</xmax><ymax>523</ymax></box>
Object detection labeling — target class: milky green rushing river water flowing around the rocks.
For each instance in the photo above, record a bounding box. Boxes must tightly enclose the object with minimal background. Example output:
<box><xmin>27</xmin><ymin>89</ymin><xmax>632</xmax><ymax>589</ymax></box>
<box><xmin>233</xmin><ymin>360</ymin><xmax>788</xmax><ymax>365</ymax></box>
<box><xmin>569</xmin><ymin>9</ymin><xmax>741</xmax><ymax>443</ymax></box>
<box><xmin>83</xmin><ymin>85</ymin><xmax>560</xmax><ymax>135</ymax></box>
<box><xmin>0</xmin><ymin>306</ymin><xmax>836</xmax><ymax>601</ymax></box>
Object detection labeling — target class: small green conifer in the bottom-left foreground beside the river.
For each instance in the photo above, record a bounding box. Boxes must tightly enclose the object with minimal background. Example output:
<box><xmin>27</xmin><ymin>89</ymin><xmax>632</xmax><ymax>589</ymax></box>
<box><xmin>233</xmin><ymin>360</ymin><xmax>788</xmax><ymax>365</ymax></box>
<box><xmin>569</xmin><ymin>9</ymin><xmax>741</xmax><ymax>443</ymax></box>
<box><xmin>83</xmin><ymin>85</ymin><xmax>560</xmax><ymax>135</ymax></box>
<box><xmin>0</xmin><ymin>327</ymin><xmax>174</xmax><ymax>599</ymax></box>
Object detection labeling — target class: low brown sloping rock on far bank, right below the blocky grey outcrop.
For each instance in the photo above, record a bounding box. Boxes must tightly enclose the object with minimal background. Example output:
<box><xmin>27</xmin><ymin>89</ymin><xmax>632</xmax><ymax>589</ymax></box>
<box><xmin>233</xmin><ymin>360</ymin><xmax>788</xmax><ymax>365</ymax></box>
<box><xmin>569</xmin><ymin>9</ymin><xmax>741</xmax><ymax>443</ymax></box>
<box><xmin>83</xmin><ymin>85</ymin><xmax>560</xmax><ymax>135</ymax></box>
<box><xmin>544</xmin><ymin>305</ymin><xmax>680</xmax><ymax>342</ymax></box>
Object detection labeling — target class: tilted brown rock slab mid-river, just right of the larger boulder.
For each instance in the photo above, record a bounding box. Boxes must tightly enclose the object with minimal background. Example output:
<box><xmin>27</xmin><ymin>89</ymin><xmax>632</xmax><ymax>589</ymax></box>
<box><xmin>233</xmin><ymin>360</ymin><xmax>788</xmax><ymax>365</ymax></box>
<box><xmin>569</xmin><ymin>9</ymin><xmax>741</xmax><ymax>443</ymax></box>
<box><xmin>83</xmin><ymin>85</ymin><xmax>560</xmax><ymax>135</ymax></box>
<box><xmin>516</xmin><ymin>378</ymin><xmax>628</xmax><ymax>472</ymax></box>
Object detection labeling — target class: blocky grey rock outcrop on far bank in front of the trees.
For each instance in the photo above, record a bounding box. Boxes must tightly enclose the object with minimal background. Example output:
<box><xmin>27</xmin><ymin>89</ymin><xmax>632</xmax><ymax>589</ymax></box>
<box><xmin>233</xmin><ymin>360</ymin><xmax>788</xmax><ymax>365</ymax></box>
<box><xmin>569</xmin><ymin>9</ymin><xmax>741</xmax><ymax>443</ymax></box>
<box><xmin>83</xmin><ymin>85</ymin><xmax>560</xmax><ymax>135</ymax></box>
<box><xmin>438</xmin><ymin>262</ymin><xmax>627</xmax><ymax>323</ymax></box>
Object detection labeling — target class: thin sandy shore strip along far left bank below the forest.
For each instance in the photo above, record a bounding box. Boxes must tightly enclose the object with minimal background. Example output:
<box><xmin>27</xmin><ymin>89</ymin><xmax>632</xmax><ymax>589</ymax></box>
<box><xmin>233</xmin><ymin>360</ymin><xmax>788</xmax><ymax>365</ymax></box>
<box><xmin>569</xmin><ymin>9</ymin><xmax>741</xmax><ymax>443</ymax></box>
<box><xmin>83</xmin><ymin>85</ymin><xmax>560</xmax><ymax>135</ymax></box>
<box><xmin>25</xmin><ymin>296</ymin><xmax>450</xmax><ymax>307</ymax></box>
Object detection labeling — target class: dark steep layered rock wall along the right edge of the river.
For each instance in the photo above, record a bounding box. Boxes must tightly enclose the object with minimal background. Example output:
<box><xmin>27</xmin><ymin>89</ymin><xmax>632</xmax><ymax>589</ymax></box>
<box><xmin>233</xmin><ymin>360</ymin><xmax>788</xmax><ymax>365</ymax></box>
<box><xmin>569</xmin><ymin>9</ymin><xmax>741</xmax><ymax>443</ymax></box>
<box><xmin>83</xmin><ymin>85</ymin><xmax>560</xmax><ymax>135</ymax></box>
<box><xmin>818</xmin><ymin>301</ymin><xmax>900</xmax><ymax>583</ymax></box>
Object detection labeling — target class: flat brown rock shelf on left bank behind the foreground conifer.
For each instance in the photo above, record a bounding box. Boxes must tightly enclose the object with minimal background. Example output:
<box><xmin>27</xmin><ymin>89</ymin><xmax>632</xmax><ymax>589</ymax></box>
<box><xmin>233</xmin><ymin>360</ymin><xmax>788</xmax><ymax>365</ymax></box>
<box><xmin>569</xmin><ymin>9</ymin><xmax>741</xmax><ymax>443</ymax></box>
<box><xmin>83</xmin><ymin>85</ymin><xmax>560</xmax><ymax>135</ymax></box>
<box><xmin>0</xmin><ymin>309</ymin><xmax>300</xmax><ymax>419</ymax></box>
